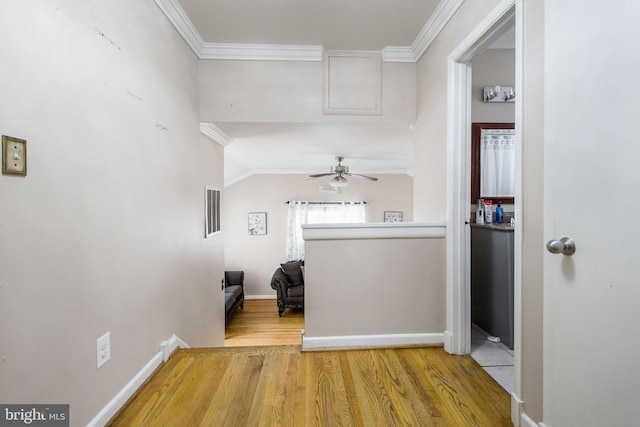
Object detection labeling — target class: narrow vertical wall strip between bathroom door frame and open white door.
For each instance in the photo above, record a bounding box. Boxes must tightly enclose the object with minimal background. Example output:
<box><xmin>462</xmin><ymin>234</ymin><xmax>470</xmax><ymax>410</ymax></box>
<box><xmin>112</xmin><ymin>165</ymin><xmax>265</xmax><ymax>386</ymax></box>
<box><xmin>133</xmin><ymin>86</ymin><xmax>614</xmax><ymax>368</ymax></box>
<box><xmin>516</xmin><ymin>1</ymin><xmax>545</xmax><ymax>421</ymax></box>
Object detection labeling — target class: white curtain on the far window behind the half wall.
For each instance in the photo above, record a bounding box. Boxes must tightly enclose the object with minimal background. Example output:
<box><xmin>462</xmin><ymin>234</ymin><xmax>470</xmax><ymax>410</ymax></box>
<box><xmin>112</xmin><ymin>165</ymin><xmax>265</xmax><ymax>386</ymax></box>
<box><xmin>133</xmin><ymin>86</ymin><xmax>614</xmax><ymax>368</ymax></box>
<box><xmin>287</xmin><ymin>201</ymin><xmax>365</xmax><ymax>261</ymax></box>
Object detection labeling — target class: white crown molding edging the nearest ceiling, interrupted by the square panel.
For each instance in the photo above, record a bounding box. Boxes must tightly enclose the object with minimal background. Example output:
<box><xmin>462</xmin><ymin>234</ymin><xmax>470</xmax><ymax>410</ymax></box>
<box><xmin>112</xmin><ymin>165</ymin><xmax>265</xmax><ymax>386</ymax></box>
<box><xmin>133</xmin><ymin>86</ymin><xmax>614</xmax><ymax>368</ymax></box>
<box><xmin>155</xmin><ymin>0</ymin><xmax>464</xmax><ymax>62</ymax></box>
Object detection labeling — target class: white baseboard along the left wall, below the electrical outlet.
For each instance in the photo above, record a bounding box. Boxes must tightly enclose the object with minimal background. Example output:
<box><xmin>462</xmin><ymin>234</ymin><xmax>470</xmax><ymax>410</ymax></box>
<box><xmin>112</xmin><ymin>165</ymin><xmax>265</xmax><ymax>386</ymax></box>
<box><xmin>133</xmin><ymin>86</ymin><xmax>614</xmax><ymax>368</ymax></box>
<box><xmin>87</xmin><ymin>335</ymin><xmax>189</xmax><ymax>427</ymax></box>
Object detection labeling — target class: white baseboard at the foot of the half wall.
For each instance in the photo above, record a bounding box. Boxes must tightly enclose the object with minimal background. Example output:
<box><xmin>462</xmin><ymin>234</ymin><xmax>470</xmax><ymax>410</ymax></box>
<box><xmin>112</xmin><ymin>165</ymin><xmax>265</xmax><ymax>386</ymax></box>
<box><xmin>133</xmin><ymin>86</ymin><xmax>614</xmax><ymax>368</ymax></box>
<box><xmin>302</xmin><ymin>333</ymin><xmax>444</xmax><ymax>351</ymax></box>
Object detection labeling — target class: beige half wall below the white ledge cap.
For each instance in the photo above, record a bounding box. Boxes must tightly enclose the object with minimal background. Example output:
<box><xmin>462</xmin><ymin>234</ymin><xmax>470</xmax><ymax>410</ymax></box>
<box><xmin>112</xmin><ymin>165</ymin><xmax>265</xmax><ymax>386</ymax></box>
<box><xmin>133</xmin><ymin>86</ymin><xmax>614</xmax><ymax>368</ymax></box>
<box><xmin>304</xmin><ymin>231</ymin><xmax>445</xmax><ymax>348</ymax></box>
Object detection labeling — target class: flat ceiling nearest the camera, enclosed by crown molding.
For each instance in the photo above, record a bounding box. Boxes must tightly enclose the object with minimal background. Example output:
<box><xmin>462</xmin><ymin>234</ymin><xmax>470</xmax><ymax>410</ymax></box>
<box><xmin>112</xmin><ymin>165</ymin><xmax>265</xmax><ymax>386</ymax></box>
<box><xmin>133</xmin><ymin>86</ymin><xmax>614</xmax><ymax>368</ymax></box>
<box><xmin>180</xmin><ymin>0</ymin><xmax>440</xmax><ymax>50</ymax></box>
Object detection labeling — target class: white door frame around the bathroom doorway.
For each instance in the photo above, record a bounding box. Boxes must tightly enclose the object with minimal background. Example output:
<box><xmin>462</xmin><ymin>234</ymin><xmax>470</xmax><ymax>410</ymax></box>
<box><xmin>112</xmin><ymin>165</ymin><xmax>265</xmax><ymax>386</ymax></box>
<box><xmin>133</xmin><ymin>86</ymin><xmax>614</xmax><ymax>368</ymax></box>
<box><xmin>444</xmin><ymin>0</ymin><xmax>524</xmax><ymax>426</ymax></box>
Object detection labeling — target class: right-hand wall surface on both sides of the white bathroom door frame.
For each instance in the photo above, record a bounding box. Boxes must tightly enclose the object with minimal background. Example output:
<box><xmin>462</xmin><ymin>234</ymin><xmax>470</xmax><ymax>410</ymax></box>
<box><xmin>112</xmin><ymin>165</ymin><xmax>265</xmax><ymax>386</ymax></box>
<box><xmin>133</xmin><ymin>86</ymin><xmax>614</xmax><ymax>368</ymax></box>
<box><xmin>414</xmin><ymin>0</ymin><xmax>544</xmax><ymax>421</ymax></box>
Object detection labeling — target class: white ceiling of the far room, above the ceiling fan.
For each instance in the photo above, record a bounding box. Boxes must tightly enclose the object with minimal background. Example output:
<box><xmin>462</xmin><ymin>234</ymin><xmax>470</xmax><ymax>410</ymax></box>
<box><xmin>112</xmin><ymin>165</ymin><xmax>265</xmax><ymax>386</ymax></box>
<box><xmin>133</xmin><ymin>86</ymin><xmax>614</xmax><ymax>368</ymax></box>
<box><xmin>218</xmin><ymin>123</ymin><xmax>413</xmax><ymax>185</ymax></box>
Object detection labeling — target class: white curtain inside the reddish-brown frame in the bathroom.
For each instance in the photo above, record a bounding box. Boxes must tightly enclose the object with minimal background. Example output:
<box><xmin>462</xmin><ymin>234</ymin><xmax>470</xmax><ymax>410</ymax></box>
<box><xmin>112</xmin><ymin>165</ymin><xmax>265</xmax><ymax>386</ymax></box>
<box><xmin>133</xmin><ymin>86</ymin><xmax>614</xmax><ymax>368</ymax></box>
<box><xmin>480</xmin><ymin>129</ymin><xmax>516</xmax><ymax>197</ymax></box>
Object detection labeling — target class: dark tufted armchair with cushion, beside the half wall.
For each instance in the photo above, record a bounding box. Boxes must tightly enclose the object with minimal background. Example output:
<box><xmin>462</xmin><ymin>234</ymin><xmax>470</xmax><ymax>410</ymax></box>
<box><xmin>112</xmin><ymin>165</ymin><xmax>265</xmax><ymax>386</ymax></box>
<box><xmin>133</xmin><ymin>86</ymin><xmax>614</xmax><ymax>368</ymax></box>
<box><xmin>271</xmin><ymin>261</ymin><xmax>304</xmax><ymax>317</ymax></box>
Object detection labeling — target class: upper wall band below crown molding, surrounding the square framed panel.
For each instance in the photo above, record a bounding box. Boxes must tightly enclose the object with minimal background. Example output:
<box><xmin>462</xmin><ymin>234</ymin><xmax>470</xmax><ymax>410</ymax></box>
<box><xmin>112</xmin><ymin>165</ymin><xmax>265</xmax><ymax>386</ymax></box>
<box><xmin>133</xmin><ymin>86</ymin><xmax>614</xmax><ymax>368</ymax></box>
<box><xmin>200</xmin><ymin>60</ymin><xmax>416</xmax><ymax>126</ymax></box>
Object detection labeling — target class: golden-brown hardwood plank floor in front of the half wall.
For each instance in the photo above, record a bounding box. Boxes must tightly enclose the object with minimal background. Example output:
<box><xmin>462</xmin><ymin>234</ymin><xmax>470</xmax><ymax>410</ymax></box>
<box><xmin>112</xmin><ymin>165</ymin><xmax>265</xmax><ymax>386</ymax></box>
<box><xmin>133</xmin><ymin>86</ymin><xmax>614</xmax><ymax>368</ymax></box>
<box><xmin>109</xmin><ymin>301</ymin><xmax>511</xmax><ymax>427</ymax></box>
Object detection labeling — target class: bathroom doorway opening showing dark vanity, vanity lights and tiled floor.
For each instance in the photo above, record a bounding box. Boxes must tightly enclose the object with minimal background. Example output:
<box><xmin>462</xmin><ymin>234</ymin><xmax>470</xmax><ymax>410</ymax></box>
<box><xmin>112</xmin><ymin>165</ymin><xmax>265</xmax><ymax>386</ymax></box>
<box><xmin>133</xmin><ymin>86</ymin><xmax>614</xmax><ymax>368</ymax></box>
<box><xmin>469</xmin><ymin>31</ymin><xmax>516</xmax><ymax>393</ymax></box>
